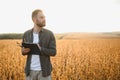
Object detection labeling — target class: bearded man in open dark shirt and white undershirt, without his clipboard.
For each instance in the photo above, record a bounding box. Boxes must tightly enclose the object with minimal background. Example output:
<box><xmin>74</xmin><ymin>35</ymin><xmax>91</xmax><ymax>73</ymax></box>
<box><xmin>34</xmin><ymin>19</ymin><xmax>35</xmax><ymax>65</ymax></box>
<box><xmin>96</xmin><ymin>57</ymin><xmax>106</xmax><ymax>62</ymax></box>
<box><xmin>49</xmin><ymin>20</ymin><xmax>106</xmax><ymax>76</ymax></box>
<box><xmin>22</xmin><ymin>9</ymin><xmax>56</xmax><ymax>80</ymax></box>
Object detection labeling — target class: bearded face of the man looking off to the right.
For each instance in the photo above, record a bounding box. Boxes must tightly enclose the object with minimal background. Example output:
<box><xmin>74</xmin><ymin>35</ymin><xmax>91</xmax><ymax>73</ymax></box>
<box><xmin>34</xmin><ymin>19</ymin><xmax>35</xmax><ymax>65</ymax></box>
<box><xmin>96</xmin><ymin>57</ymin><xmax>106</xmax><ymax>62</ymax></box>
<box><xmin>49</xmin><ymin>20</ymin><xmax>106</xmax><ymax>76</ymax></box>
<box><xmin>35</xmin><ymin>12</ymin><xmax>46</xmax><ymax>27</ymax></box>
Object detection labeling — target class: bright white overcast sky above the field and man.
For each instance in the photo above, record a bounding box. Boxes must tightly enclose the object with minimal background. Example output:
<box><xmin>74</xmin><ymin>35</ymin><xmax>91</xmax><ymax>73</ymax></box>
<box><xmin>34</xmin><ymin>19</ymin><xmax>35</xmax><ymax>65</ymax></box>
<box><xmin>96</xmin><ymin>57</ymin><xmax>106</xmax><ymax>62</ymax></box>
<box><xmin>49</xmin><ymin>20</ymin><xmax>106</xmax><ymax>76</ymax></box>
<box><xmin>0</xmin><ymin>0</ymin><xmax>120</xmax><ymax>33</ymax></box>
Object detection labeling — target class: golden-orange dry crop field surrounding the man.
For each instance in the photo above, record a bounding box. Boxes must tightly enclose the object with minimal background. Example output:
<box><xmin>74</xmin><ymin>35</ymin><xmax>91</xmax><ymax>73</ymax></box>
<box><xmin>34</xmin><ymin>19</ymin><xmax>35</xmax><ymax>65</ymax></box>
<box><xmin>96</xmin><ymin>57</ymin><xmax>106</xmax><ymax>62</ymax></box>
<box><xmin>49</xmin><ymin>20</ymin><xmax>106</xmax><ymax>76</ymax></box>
<box><xmin>0</xmin><ymin>38</ymin><xmax>120</xmax><ymax>80</ymax></box>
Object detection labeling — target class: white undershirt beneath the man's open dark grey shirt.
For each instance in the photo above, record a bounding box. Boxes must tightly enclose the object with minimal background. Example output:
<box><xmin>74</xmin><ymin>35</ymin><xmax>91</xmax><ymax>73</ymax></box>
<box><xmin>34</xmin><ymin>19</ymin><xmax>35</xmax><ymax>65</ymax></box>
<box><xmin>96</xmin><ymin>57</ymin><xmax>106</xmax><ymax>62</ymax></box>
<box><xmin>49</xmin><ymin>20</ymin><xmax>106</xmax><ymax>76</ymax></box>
<box><xmin>30</xmin><ymin>33</ymin><xmax>41</xmax><ymax>70</ymax></box>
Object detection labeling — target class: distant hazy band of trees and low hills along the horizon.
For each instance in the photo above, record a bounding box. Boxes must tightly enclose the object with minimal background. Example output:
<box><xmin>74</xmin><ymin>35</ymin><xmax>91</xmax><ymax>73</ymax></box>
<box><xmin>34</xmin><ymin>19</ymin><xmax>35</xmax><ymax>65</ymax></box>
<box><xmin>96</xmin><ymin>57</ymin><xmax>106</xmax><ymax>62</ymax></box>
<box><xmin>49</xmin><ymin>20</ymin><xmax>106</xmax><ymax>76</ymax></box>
<box><xmin>0</xmin><ymin>31</ymin><xmax>120</xmax><ymax>39</ymax></box>
